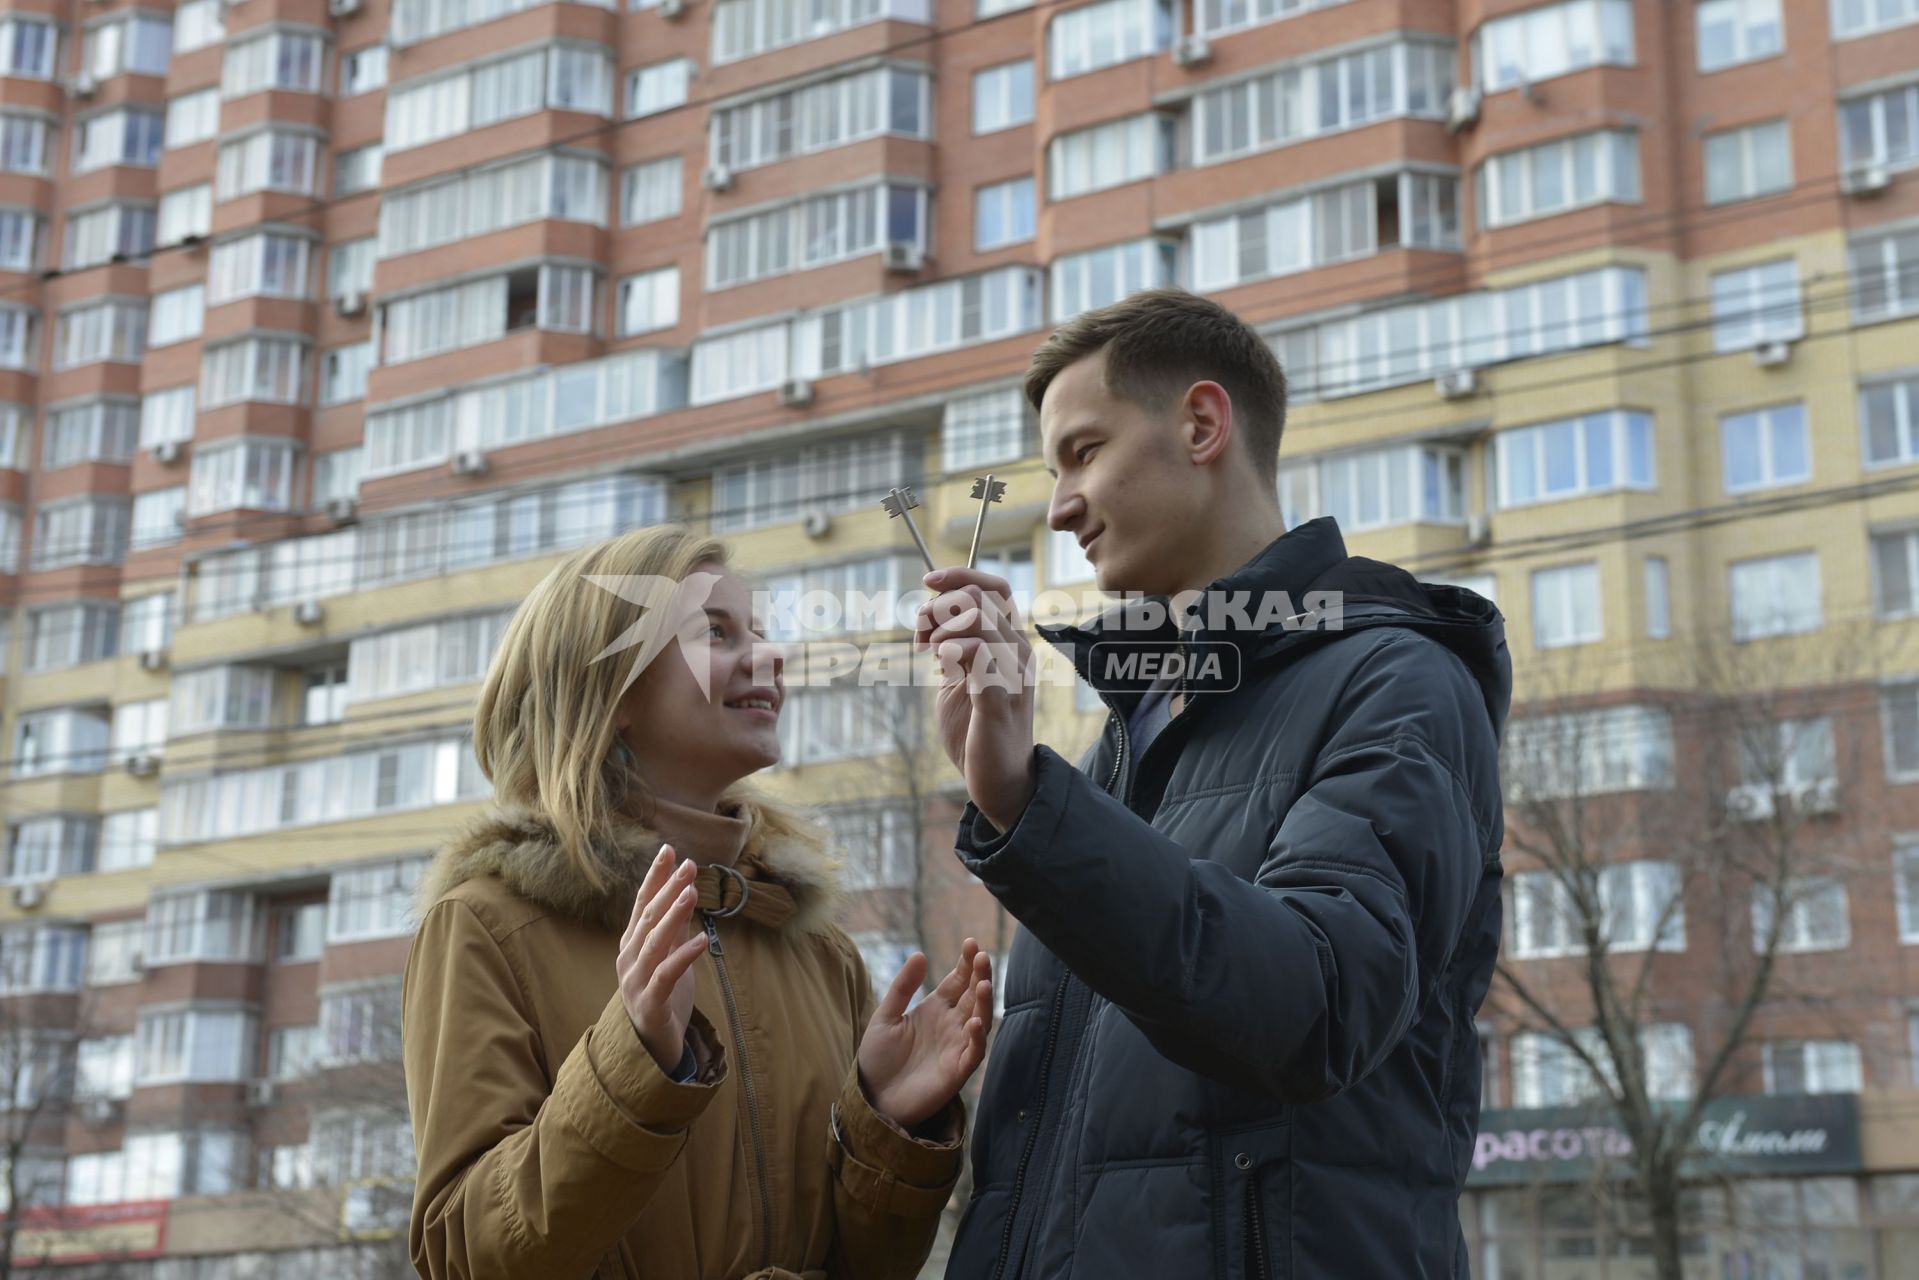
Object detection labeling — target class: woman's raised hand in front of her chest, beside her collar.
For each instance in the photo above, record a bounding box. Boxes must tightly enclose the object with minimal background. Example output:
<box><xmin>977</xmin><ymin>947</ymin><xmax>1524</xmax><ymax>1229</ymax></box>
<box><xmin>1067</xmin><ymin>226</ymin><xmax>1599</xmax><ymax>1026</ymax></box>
<box><xmin>616</xmin><ymin>844</ymin><xmax>706</xmax><ymax>1075</ymax></box>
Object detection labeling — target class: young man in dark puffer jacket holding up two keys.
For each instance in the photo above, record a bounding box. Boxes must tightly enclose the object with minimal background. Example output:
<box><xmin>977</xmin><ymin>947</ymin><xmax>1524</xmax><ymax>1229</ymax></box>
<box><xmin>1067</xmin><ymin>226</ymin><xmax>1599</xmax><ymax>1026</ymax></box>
<box><xmin>915</xmin><ymin>290</ymin><xmax>1510</xmax><ymax>1280</ymax></box>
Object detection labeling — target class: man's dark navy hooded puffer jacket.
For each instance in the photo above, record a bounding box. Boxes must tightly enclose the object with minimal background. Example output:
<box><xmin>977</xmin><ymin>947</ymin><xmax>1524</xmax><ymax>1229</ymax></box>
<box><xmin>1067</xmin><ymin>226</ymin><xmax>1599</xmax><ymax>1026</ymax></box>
<box><xmin>946</xmin><ymin>520</ymin><xmax>1512</xmax><ymax>1280</ymax></box>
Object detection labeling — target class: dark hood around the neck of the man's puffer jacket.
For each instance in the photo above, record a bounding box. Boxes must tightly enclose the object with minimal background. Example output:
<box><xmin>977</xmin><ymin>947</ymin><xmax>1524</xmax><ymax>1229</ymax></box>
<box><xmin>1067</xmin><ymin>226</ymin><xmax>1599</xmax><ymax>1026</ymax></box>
<box><xmin>1034</xmin><ymin>516</ymin><xmax>1512</xmax><ymax>737</ymax></box>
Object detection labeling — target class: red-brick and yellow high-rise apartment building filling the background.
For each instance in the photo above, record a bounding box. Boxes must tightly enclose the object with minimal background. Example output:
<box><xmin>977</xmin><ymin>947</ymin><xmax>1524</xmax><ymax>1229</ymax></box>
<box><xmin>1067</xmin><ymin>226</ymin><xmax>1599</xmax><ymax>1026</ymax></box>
<box><xmin>0</xmin><ymin>0</ymin><xmax>1919</xmax><ymax>1280</ymax></box>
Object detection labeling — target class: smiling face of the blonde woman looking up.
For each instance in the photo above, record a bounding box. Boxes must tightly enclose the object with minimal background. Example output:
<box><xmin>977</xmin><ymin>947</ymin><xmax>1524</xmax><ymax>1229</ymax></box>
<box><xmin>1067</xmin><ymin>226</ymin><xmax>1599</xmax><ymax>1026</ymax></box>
<box><xmin>618</xmin><ymin>564</ymin><xmax>785</xmax><ymax>804</ymax></box>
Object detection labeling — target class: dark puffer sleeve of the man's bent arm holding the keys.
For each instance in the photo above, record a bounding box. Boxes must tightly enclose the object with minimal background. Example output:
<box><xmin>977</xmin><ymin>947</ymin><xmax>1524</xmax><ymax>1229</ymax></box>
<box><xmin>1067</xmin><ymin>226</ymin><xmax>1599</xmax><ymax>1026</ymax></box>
<box><xmin>958</xmin><ymin>633</ymin><xmax>1499</xmax><ymax>1102</ymax></box>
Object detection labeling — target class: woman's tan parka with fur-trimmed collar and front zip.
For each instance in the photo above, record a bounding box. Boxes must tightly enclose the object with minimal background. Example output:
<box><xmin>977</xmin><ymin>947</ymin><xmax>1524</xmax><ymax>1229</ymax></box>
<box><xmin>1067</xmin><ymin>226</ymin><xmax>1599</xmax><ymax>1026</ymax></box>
<box><xmin>405</xmin><ymin>798</ymin><xmax>963</xmax><ymax>1280</ymax></box>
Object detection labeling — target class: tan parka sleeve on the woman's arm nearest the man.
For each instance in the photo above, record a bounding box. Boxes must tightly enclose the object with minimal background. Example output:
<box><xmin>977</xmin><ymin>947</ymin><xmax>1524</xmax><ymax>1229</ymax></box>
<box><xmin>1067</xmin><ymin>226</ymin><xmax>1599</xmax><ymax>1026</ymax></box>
<box><xmin>827</xmin><ymin>940</ymin><xmax>965</xmax><ymax>1280</ymax></box>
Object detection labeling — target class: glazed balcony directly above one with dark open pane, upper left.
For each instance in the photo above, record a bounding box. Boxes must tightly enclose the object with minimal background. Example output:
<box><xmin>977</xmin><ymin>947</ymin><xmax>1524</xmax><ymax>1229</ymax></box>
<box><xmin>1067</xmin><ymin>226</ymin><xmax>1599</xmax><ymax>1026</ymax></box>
<box><xmin>378</xmin><ymin>154</ymin><xmax>602</xmax><ymax>257</ymax></box>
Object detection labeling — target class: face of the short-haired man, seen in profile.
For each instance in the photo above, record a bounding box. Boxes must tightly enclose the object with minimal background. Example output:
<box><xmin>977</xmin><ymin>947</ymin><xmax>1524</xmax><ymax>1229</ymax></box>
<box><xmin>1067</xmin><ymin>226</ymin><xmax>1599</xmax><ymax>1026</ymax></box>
<box><xmin>1040</xmin><ymin>351</ymin><xmax>1207</xmax><ymax>595</ymax></box>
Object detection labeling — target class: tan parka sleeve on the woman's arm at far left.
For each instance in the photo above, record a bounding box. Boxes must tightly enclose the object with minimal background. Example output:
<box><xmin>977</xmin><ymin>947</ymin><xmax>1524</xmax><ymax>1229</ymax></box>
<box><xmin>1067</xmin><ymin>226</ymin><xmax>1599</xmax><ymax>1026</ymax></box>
<box><xmin>403</xmin><ymin>898</ymin><xmax>725</xmax><ymax>1280</ymax></box>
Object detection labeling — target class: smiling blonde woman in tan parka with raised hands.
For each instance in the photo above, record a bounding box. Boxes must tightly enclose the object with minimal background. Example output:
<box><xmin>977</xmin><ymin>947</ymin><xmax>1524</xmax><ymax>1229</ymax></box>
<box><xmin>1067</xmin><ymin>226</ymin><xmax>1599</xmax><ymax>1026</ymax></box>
<box><xmin>405</xmin><ymin>526</ymin><xmax>992</xmax><ymax>1280</ymax></box>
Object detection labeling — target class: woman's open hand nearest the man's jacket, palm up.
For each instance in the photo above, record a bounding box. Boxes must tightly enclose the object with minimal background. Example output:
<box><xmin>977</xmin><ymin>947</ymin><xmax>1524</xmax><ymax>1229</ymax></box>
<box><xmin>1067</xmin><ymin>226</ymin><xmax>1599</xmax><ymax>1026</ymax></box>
<box><xmin>860</xmin><ymin>938</ymin><xmax>992</xmax><ymax>1128</ymax></box>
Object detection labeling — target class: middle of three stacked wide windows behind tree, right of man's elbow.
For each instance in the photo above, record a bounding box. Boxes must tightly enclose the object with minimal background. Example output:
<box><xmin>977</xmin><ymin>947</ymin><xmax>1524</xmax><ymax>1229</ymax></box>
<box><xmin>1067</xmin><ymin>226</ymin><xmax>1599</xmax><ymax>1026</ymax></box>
<box><xmin>1512</xmin><ymin>862</ymin><xmax>1685</xmax><ymax>960</ymax></box>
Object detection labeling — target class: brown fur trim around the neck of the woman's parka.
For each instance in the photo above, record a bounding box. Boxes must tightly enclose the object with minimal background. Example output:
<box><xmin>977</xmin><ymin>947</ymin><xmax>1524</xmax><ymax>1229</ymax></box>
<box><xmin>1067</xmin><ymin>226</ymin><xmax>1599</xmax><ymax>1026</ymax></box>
<box><xmin>416</xmin><ymin>789</ymin><xmax>841</xmax><ymax>933</ymax></box>
